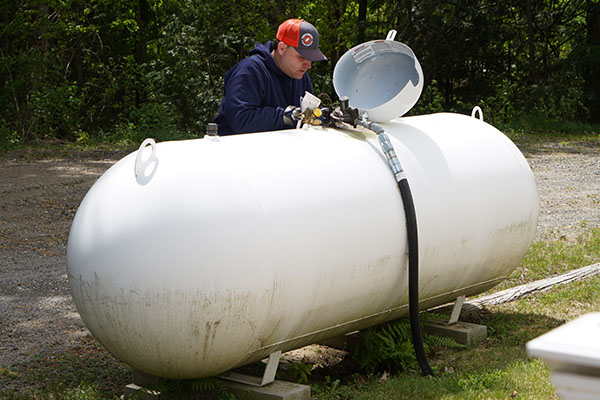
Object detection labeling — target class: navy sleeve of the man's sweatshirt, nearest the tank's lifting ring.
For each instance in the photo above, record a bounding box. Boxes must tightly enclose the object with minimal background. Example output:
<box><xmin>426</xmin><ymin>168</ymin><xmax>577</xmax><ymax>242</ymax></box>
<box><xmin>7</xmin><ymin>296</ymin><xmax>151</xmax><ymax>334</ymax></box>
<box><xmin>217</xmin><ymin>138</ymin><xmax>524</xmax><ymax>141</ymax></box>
<box><xmin>224</xmin><ymin>69</ymin><xmax>285</xmax><ymax>133</ymax></box>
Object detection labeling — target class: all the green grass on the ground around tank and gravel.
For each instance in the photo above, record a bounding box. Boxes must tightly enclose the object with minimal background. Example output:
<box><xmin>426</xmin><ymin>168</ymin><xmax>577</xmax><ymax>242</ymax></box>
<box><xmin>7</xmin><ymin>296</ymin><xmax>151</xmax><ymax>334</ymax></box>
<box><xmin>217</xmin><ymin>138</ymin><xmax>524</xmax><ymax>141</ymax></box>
<box><xmin>0</xmin><ymin>131</ymin><xmax>600</xmax><ymax>400</ymax></box>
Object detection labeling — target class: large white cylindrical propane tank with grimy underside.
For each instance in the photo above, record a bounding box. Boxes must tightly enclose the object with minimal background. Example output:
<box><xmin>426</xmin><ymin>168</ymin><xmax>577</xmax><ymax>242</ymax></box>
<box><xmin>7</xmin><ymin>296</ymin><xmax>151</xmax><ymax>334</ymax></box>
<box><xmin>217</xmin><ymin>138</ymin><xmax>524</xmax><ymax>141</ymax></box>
<box><xmin>68</xmin><ymin>113</ymin><xmax>538</xmax><ymax>379</ymax></box>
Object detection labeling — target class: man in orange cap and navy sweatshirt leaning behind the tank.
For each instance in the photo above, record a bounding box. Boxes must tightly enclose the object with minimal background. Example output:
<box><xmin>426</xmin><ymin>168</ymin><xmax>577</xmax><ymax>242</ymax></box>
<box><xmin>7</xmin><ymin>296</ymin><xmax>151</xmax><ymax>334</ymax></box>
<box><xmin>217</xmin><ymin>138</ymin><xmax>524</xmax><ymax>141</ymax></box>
<box><xmin>215</xmin><ymin>19</ymin><xmax>327</xmax><ymax>135</ymax></box>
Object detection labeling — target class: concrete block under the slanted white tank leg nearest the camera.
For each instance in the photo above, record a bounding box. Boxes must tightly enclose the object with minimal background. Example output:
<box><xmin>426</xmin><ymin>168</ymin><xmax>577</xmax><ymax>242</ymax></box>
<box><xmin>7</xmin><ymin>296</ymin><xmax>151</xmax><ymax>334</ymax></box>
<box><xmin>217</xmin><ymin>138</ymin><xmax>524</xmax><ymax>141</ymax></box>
<box><xmin>223</xmin><ymin>380</ymin><xmax>310</xmax><ymax>400</ymax></box>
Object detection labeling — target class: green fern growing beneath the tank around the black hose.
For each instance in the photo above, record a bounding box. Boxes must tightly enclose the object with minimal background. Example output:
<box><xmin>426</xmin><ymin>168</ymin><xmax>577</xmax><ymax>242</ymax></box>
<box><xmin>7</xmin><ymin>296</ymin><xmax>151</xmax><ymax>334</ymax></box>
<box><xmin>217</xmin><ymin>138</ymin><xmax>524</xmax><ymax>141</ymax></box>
<box><xmin>353</xmin><ymin>319</ymin><xmax>464</xmax><ymax>371</ymax></box>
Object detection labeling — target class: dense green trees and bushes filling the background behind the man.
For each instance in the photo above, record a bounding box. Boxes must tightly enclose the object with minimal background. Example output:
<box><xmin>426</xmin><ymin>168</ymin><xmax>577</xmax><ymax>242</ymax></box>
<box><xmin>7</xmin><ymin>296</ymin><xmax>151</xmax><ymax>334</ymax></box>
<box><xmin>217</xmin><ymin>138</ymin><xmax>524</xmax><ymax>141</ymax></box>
<box><xmin>0</xmin><ymin>0</ymin><xmax>600</xmax><ymax>141</ymax></box>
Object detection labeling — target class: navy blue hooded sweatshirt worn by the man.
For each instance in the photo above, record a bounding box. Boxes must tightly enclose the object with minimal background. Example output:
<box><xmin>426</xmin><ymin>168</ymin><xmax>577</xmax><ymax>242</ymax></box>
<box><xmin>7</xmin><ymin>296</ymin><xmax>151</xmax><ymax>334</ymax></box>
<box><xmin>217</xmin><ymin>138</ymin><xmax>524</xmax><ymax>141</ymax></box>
<box><xmin>214</xmin><ymin>42</ymin><xmax>313</xmax><ymax>135</ymax></box>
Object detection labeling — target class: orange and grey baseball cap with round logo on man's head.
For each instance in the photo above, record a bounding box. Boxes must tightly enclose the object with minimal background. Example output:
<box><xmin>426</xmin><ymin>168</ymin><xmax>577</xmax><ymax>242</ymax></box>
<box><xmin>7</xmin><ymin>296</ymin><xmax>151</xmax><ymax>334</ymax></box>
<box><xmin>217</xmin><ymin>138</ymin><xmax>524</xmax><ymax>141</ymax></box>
<box><xmin>277</xmin><ymin>19</ymin><xmax>327</xmax><ymax>61</ymax></box>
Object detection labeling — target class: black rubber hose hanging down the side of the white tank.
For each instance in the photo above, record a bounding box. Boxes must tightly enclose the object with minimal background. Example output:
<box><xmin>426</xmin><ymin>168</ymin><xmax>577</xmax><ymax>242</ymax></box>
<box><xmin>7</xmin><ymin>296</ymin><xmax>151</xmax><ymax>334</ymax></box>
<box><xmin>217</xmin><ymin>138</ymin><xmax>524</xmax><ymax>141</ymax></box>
<box><xmin>398</xmin><ymin>178</ymin><xmax>433</xmax><ymax>375</ymax></box>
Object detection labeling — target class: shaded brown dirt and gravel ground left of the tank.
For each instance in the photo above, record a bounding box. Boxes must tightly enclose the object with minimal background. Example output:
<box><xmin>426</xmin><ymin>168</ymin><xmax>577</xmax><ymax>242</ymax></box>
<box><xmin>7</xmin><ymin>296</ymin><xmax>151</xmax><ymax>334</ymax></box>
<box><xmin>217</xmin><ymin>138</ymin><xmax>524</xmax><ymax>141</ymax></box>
<box><xmin>0</xmin><ymin>154</ymin><xmax>127</xmax><ymax>365</ymax></box>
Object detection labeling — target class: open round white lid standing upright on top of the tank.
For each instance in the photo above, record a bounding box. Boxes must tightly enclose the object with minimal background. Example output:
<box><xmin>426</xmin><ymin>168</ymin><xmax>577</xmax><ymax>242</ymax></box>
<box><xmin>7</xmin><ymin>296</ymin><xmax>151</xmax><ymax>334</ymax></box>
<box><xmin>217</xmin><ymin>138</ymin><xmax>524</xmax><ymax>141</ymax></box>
<box><xmin>333</xmin><ymin>30</ymin><xmax>423</xmax><ymax>122</ymax></box>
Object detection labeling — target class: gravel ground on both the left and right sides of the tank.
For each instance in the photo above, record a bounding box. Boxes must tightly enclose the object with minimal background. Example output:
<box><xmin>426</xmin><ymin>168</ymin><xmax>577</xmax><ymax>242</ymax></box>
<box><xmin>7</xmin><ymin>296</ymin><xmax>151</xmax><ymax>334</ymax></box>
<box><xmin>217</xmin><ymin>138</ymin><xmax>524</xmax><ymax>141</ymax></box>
<box><xmin>0</xmin><ymin>141</ymin><xmax>600</xmax><ymax>380</ymax></box>
